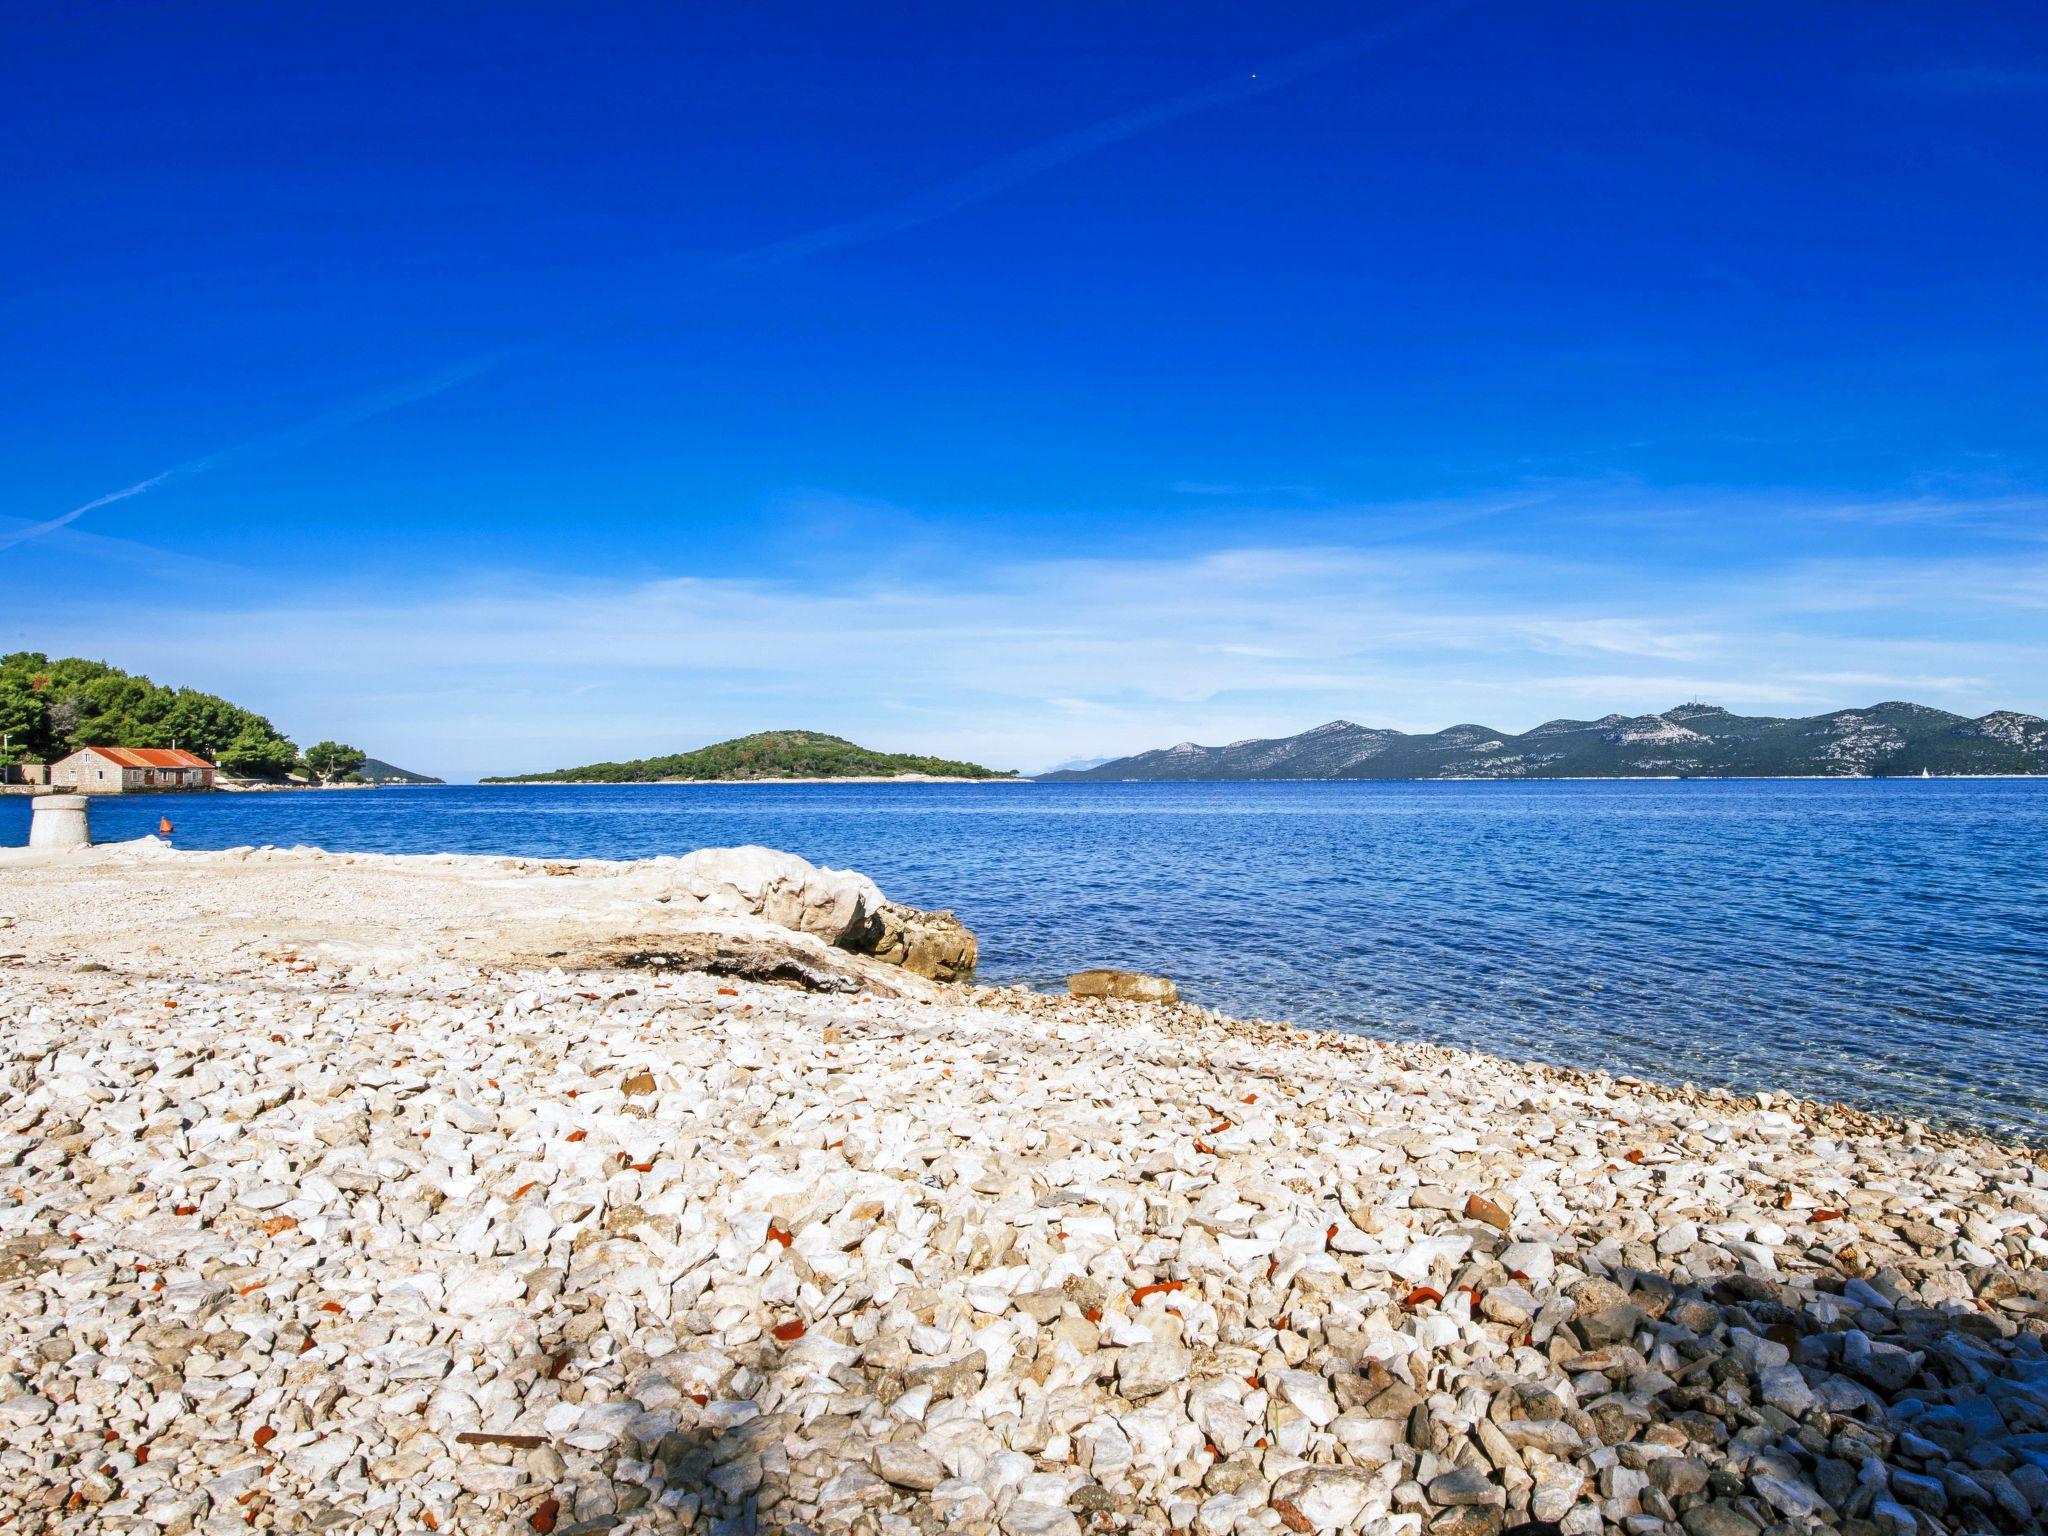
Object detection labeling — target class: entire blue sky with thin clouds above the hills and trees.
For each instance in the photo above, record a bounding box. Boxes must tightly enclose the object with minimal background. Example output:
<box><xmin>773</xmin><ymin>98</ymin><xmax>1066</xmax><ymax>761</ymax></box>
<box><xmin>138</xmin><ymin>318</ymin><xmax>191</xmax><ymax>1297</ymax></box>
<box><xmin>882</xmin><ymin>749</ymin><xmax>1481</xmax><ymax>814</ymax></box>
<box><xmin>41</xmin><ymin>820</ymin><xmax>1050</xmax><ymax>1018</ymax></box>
<box><xmin>0</xmin><ymin>2</ymin><xmax>2048</xmax><ymax>776</ymax></box>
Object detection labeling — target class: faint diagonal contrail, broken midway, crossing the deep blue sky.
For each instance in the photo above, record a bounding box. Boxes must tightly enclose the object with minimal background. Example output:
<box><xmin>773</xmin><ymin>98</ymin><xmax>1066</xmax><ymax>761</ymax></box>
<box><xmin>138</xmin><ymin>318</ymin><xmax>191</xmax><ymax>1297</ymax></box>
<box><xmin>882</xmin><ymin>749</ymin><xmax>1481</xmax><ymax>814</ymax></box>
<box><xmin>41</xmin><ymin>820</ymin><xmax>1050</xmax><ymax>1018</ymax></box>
<box><xmin>0</xmin><ymin>0</ymin><xmax>1473</xmax><ymax>549</ymax></box>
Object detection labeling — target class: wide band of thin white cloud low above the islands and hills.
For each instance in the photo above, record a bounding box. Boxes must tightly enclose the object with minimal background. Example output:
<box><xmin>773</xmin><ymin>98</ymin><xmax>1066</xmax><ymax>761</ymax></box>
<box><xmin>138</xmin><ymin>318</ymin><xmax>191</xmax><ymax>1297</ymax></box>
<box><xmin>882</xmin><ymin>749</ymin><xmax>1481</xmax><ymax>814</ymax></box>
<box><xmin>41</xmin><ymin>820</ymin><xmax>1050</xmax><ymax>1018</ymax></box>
<box><xmin>19</xmin><ymin>495</ymin><xmax>2048</xmax><ymax>776</ymax></box>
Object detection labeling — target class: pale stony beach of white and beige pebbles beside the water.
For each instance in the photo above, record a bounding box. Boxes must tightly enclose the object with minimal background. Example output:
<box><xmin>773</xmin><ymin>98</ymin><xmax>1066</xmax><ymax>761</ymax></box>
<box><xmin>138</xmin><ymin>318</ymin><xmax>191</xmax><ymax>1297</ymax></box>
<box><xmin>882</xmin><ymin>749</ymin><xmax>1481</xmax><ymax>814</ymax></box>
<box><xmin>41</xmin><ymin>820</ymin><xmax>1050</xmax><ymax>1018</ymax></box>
<box><xmin>0</xmin><ymin>847</ymin><xmax>2048</xmax><ymax>1536</ymax></box>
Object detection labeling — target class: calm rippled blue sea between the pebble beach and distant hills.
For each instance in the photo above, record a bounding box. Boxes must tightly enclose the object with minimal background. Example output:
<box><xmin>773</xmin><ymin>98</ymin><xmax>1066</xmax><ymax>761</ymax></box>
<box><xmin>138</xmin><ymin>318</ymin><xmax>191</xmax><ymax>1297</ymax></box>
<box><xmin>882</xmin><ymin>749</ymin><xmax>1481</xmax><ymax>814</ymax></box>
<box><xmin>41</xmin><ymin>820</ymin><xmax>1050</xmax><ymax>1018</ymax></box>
<box><xmin>0</xmin><ymin>780</ymin><xmax>2048</xmax><ymax>1141</ymax></box>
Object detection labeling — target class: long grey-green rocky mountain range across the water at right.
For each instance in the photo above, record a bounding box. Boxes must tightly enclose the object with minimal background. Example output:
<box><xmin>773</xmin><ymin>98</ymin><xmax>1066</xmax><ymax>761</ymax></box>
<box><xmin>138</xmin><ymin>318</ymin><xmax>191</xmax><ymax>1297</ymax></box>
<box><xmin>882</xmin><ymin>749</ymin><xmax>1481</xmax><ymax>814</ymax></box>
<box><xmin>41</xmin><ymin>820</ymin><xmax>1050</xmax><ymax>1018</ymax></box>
<box><xmin>1040</xmin><ymin>702</ymin><xmax>2048</xmax><ymax>782</ymax></box>
